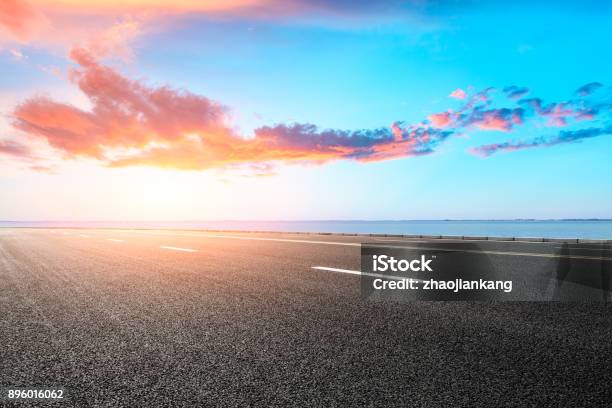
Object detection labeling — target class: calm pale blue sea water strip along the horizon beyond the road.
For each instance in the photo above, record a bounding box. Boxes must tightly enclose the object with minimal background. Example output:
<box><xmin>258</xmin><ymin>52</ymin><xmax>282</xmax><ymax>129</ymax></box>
<box><xmin>0</xmin><ymin>220</ymin><xmax>612</xmax><ymax>239</ymax></box>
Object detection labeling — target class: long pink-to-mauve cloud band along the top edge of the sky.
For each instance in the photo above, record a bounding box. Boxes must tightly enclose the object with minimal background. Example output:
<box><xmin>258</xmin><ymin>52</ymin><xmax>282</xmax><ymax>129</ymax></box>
<box><xmin>0</xmin><ymin>0</ymin><xmax>424</xmax><ymax>47</ymax></box>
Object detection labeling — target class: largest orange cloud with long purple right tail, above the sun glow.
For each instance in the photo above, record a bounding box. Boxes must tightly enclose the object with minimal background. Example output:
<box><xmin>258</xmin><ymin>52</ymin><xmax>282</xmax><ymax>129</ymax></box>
<box><xmin>13</xmin><ymin>48</ymin><xmax>450</xmax><ymax>170</ymax></box>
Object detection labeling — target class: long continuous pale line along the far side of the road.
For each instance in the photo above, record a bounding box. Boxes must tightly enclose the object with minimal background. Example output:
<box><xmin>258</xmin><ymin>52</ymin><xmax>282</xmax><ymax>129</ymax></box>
<box><xmin>103</xmin><ymin>231</ymin><xmax>612</xmax><ymax>261</ymax></box>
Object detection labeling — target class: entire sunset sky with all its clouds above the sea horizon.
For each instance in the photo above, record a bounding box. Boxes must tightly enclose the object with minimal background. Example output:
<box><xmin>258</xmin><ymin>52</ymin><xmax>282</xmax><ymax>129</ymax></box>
<box><xmin>0</xmin><ymin>0</ymin><xmax>612</xmax><ymax>221</ymax></box>
